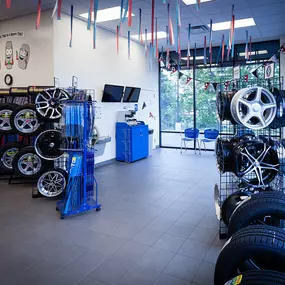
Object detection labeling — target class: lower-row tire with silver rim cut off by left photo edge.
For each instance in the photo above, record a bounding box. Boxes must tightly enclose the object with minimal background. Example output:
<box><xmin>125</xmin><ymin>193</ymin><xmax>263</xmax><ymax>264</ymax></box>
<box><xmin>0</xmin><ymin>142</ymin><xmax>22</xmax><ymax>173</ymax></box>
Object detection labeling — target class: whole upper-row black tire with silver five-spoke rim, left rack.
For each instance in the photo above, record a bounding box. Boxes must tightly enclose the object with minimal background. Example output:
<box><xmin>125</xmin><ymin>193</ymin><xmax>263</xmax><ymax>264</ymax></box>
<box><xmin>11</xmin><ymin>104</ymin><xmax>42</xmax><ymax>136</ymax></box>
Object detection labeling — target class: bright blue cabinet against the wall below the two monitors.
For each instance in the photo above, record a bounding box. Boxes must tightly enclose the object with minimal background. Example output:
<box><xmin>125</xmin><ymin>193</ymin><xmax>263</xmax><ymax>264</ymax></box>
<box><xmin>116</xmin><ymin>122</ymin><xmax>149</xmax><ymax>163</ymax></box>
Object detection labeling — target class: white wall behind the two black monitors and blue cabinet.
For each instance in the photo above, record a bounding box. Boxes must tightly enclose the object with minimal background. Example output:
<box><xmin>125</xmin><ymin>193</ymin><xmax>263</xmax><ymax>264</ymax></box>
<box><xmin>54</xmin><ymin>15</ymin><xmax>159</xmax><ymax>162</ymax></box>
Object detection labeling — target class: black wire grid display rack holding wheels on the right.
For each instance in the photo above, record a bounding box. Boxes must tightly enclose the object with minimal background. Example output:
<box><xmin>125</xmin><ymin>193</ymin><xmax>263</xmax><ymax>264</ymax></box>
<box><xmin>215</xmin><ymin>80</ymin><xmax>285</xmax><ymax>239</ymax></box>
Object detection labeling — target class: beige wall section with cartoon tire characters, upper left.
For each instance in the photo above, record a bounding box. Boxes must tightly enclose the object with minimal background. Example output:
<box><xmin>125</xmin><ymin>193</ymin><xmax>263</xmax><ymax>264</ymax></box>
<box><xmin>0</xmin><ymin>11</ymin><xmax>54</xmax><ymax>88</ymax></box>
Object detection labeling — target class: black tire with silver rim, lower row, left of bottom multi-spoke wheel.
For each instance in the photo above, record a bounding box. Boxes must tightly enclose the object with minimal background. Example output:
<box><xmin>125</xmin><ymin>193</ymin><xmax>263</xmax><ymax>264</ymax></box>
<box><xmin>12</xmin><ymin>146</ymin><xmax>53</xmax><ymax>179</ymax></box>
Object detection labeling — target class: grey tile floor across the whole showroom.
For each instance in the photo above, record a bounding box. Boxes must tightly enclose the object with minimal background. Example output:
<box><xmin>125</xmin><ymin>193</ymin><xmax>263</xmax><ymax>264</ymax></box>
<box><xmin>0</xmin><ymin>149</ymin><xmax>223</xmax><ymax>285</ymax></box>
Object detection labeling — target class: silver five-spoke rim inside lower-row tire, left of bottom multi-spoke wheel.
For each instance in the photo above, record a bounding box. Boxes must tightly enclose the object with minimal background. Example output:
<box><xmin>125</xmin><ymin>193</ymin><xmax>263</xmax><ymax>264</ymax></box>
<box><xmin>18</xmin><ymin>153</ymin><xmax>42</xmax><ymax>176</ymax></box>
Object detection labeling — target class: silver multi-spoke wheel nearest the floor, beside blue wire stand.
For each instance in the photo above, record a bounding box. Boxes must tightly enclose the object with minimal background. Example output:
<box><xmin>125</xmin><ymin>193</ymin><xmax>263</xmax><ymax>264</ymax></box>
<box><xmin>37</xmin><ymin>168</ymin><xmax>68</xmax><ymax>198</ymax></box>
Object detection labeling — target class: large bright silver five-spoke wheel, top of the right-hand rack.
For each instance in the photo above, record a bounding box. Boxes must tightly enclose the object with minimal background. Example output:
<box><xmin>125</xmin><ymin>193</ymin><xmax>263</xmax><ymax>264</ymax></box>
<box><xmin>231</xmin><ymin>87</ymin><xmax>277</xmax><ymax>130</ymax></box>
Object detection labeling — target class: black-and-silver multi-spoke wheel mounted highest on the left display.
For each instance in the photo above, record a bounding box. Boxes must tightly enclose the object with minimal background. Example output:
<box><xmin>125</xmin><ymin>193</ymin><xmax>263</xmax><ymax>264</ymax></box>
<box><xmin>35</xmin><ymin>88</ymin><xmax>71</xmax><ymax>121</ymax></box>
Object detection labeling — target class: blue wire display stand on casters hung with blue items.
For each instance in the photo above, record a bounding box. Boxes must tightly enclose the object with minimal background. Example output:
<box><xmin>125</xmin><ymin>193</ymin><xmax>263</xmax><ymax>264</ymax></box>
<box><xmin>57</xmin><ymin>93</ymin><xmax>101</xmax><ymax>219</ymax></box>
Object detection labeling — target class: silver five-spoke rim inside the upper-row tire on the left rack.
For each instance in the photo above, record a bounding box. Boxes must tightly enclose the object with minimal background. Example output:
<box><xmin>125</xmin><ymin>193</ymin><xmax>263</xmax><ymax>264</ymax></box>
<box><xmin>14</xmin><ymin>109</ymin><xmax>40</xmax><ymax>134</ymax></box>
